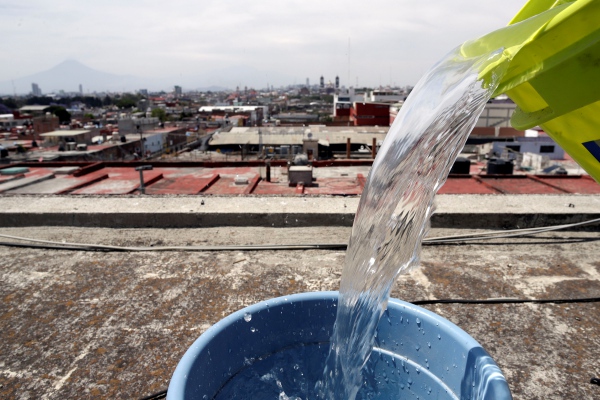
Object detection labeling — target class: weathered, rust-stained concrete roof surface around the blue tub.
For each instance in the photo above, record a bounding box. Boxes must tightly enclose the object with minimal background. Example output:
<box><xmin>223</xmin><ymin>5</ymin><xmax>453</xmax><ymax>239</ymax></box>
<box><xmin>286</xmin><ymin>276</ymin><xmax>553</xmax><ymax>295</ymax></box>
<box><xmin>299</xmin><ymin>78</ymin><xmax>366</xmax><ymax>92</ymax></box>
<box><xmin>0</xmin><ymin>227</ymin><xmax>600</xmax><ymax>399</ymax></box>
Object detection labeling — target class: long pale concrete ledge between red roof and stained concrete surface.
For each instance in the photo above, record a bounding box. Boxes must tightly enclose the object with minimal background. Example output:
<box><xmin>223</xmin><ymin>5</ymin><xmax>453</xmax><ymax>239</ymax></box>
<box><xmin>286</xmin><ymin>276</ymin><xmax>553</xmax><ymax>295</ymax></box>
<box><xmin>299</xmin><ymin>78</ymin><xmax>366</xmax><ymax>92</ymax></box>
<box><xmin>0</xmin><ymin>195</ymin><xmax>600</xmax><ymax>229</ymax></box>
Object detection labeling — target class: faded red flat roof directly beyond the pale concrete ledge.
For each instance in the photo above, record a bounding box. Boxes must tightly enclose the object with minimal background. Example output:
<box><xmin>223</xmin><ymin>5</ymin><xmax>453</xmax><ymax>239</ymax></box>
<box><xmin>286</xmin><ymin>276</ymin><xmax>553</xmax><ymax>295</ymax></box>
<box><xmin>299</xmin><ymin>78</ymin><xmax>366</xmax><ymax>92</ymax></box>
<box><xmin>0</xmin><ymin>161</ymin><xmax>600</xmax><ymax>196</ymax></box>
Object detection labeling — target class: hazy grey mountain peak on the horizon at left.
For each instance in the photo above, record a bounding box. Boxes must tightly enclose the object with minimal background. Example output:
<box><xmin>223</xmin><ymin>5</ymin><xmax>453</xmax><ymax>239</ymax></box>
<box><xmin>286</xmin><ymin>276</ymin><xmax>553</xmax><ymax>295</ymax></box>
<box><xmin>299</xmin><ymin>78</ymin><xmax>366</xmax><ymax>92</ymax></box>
<box><xmin>0</xmin><ymin>60</ymin><xmax>144</xmax><ymax>94</ymax></box>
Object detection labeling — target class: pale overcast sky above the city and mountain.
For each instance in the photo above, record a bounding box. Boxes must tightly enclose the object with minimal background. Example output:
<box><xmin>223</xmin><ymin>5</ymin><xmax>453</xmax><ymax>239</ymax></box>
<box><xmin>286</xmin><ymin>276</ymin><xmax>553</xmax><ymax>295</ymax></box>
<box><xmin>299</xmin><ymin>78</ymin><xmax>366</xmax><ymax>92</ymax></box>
<box><xmin>0</xmin><ymin>0</ymin><xmax>525</xmax><ymax>91</ymax></box>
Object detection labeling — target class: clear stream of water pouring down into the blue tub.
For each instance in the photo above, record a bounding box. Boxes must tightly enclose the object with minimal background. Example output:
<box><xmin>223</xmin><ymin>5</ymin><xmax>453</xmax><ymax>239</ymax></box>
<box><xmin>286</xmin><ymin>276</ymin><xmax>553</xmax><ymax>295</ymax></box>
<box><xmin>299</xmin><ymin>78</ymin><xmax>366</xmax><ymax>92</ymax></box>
<box><xmin>316</xmin><ymin>49</ymin><xmax>503</xmax><ymax>400</ymax></box>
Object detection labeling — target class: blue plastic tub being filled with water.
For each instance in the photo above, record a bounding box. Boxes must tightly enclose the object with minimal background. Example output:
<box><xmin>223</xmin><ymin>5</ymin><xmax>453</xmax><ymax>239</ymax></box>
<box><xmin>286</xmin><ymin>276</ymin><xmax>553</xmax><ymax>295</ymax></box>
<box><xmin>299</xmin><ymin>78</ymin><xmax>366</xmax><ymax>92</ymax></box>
<box><xmin>167</xmin><ymin>292</ymin><xmax>512</xmax><ymax>400</ymax></box>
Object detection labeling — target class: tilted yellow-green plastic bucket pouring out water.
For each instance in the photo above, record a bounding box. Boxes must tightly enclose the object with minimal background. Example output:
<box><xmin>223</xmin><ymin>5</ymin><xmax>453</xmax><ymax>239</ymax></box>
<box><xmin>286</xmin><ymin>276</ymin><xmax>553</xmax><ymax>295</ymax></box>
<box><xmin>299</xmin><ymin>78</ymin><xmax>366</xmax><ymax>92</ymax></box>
<box><xmin>461</xmin><ymin>0</ymin><xmax>600</xmax><ymax>182</ymax></box>
